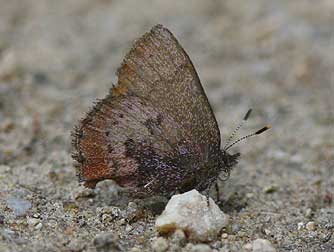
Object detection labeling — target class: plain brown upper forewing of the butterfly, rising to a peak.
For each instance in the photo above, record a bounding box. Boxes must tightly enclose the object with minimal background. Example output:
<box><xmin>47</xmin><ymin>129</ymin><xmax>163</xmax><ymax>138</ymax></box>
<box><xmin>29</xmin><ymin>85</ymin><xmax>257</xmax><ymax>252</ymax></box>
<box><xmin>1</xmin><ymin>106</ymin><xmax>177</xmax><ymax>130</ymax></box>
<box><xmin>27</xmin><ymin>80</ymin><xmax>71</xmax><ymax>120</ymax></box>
<box><xmin>118</xmin><ymin>25</ymin><xmax>220</xmax><ymax>154</ymax></box>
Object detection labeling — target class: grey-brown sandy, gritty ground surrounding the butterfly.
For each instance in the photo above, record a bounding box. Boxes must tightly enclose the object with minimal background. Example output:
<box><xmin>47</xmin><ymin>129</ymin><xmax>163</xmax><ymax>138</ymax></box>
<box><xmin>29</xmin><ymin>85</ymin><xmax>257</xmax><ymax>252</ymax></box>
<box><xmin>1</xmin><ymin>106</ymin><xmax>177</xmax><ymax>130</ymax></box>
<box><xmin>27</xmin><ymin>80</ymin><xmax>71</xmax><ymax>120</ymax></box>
<box><xmin>0</xmin><ymin>0</ymin><xmax>334</xmax><ymax>252</ymax></box>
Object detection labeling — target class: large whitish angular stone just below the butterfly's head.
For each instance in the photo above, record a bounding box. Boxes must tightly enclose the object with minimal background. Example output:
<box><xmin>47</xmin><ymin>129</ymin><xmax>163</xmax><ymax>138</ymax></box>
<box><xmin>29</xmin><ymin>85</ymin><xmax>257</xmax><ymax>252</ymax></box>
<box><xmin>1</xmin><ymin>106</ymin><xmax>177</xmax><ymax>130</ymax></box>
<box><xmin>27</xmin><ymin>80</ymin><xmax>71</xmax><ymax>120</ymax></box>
<box><xmin>155</xmin><ymin>190</ymin><xmax>228</xmax><ymax>241</ymax></box>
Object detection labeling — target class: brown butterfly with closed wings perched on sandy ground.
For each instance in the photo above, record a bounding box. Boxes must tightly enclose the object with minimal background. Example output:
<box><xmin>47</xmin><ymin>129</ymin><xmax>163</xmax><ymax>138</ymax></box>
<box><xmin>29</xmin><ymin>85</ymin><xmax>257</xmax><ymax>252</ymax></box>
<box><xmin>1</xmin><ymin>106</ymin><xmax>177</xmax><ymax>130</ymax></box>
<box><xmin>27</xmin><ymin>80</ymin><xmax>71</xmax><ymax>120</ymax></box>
<box><xmin>72</xmin><ymin>25</ymin><xmax>267</xmax><ymax>196</ymax></box>
